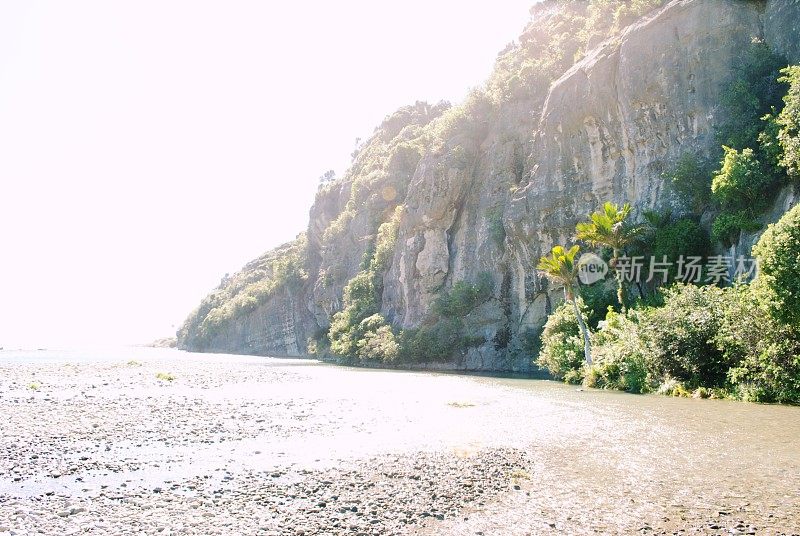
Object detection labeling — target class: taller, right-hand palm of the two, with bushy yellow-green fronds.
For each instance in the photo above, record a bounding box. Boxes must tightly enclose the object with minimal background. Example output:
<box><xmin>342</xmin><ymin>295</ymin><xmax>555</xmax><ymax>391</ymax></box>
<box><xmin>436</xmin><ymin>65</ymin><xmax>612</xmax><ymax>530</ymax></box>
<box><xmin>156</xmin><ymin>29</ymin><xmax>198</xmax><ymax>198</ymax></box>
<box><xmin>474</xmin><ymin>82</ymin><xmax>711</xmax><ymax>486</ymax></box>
<box><xmin>575</xmin><ymin>202</ymin><xmax>642</xmax><ymax>310</ymax></box>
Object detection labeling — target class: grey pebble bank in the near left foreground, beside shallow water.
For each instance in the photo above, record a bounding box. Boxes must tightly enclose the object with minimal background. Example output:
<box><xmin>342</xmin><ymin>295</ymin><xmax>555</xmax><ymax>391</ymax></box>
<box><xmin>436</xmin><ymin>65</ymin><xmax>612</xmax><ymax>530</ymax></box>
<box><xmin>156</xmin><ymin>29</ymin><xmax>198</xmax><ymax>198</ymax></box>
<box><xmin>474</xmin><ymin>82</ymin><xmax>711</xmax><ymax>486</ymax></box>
<box><xmin>0</xmin><ymin>451</ymin><xmax>526</xmax><ymax>535</ymax></box>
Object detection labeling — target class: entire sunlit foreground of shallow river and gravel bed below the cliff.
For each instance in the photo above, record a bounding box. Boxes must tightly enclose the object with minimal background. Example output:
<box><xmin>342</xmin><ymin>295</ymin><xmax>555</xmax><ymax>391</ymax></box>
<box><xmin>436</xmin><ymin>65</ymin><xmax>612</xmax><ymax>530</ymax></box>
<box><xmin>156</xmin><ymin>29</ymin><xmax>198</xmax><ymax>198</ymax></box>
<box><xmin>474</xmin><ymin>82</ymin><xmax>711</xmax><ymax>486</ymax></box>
<box><xmin>0</xmin><ymin>350</ymin><xmax>800</xmax><ymax>534</ymax></box>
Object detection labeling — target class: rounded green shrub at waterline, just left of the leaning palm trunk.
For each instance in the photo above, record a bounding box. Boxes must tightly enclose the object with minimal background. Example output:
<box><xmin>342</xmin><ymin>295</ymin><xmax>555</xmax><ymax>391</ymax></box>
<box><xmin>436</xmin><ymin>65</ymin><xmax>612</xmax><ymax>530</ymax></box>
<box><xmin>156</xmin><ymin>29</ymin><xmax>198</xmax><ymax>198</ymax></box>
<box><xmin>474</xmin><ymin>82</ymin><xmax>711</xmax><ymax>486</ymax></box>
<box><xmin>536</xmin><ymin>298</ymin><xmax>586</xmax><ymax>383</ymax></box>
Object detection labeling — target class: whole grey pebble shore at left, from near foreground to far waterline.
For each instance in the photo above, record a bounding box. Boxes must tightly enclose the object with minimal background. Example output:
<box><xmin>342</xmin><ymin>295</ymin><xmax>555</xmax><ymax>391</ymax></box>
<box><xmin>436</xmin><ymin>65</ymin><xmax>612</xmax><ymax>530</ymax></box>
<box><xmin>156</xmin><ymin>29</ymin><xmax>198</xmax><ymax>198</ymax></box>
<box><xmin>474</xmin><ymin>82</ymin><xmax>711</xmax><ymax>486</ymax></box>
<box><xmin>0</xmin><ymin>352</ymin><xmax>530</xmax><ymax>535</ymax></box>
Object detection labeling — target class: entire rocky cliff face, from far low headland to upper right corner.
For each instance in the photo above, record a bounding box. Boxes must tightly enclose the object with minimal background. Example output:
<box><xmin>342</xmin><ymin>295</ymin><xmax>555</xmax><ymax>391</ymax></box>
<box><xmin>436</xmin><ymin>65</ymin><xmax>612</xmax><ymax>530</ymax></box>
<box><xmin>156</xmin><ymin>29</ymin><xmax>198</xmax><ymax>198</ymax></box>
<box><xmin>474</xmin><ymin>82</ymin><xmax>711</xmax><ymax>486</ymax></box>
<box><xmin>181</xmin><ymin>0</ymin><xmax>800</xmax><ymax>371</ymax></box>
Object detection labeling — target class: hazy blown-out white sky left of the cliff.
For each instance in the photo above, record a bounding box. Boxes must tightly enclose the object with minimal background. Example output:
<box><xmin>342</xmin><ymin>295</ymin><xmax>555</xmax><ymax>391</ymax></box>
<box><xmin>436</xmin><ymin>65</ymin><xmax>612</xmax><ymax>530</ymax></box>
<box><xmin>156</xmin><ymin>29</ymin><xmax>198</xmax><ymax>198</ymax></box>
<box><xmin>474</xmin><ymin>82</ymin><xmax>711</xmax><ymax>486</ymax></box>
<box><xmin>0</xmin><ymin>0</ymin><xmax>533</xmax><ymax>348</ymax></box>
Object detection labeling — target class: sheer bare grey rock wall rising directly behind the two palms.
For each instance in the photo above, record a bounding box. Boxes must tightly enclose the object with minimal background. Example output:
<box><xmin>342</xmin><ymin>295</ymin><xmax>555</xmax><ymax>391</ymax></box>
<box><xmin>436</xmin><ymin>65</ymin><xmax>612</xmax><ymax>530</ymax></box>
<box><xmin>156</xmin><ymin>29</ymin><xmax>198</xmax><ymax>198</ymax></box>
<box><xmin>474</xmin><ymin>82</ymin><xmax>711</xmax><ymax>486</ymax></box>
<box><xmin>507</xmin><ymin>0</ymin><xmax>762</xmax><ymax>344</ymax></box>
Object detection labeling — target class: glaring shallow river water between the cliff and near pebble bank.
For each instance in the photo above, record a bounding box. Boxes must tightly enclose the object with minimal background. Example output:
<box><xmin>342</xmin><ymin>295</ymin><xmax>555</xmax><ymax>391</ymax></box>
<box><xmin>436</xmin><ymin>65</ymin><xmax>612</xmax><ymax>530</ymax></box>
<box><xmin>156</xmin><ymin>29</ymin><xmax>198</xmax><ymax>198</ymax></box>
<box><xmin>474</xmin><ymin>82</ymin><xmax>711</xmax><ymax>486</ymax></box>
<box><xmin>0</xmin><ymin>349</ymin><xmax>800</xmax><ymax>533</ymax></box>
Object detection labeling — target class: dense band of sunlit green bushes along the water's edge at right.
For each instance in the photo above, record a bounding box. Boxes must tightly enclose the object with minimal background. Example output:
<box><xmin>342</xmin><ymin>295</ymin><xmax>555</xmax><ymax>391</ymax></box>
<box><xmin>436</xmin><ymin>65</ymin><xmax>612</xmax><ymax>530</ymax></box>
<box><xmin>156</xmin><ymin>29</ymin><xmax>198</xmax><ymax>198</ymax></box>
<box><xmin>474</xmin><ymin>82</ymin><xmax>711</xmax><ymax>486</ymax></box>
<box><xmin>537</xmin><ymin>206</ymin><xmax>800</xmax><ymax>403</ymax></box>
